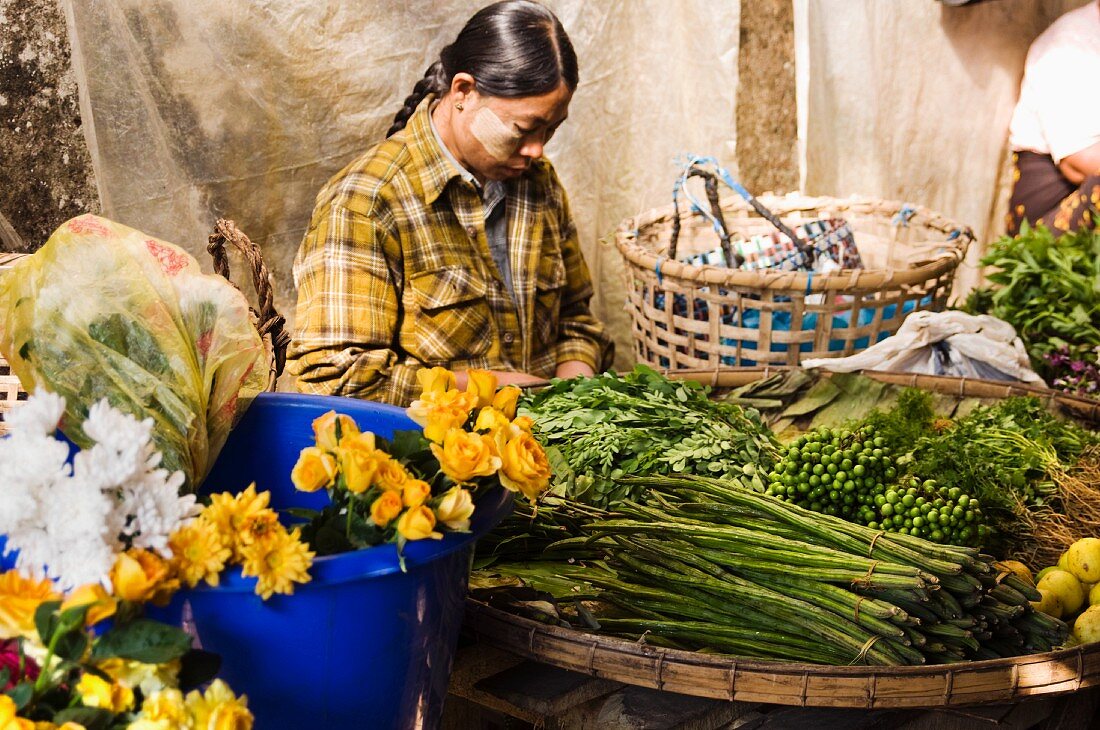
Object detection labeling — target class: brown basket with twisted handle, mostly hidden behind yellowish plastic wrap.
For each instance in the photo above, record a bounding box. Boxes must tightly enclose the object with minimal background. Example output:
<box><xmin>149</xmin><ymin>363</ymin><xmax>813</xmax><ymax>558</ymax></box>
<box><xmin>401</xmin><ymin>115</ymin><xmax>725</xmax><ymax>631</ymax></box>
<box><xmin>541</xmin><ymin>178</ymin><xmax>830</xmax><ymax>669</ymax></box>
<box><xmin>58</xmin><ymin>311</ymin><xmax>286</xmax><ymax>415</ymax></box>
<box><xmin>0</xmin><ymin>220</ymin><xmax>290</xmax><ymax>436</ymax></box>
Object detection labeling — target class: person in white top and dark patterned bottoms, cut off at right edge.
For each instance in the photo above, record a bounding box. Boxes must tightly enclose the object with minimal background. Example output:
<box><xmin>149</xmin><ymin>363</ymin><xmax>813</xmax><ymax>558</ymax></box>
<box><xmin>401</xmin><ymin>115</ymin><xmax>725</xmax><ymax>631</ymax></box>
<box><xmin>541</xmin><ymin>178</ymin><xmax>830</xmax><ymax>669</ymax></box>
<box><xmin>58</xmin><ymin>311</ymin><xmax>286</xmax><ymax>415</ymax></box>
<box><xmin>1008</xmin><ymin>0</ymin><xmax>1100</xmax><ymax>234</ymax></box>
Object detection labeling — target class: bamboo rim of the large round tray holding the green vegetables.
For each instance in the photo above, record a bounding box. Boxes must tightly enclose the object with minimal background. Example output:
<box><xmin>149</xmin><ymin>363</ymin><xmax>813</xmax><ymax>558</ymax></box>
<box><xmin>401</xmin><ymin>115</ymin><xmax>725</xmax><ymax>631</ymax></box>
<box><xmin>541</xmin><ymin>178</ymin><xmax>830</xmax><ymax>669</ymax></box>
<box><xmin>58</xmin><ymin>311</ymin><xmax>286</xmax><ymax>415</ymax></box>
<box><xmin>465</xmin><ymin>368</ymin><xmax>1100</xmax><ymax>708</ymax></box>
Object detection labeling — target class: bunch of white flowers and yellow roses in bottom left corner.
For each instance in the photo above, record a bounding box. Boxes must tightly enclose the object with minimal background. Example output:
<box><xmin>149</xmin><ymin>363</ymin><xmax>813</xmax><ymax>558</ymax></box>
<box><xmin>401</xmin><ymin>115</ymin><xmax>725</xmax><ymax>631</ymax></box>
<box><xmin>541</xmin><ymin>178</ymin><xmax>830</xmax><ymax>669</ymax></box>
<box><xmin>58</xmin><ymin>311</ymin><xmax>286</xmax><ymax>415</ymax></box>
<box><xmin>0</xmin><ymin>392</ymin><xmax>252</xmax><ymax>730</ymax></box>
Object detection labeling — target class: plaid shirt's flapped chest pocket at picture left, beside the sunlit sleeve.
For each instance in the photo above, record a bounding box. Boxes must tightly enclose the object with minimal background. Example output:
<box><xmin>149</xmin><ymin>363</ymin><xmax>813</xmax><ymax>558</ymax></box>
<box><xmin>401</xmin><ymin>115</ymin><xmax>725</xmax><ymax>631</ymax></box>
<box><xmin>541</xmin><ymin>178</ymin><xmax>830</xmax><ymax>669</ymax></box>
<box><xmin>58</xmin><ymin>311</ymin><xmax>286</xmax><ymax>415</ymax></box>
<box><xmin>408</xmin><ymin>266</ymin><xmax>493</xmax><ymax>366</ymax></box>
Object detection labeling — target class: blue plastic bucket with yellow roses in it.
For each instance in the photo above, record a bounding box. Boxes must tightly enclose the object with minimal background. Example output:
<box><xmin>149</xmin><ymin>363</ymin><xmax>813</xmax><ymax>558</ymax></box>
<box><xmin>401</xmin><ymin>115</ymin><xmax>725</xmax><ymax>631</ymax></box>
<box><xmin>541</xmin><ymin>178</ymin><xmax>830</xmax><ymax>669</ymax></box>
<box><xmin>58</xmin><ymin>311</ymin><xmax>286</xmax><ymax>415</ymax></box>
<box><xmin>170</xmin><ymin>368</ymin><xmax>550</xmax><ymax>729</ymax></box>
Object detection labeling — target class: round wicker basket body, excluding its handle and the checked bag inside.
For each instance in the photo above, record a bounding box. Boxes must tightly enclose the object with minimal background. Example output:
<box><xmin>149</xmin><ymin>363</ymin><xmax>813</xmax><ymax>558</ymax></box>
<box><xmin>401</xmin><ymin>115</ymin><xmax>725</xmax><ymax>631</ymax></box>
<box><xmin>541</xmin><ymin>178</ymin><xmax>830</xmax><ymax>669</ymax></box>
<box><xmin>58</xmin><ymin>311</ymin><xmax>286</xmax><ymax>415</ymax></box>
<box><xmin>615</xmin><ymin>195</ymin><xmax>974</xmax><ymax>370</ymax></box>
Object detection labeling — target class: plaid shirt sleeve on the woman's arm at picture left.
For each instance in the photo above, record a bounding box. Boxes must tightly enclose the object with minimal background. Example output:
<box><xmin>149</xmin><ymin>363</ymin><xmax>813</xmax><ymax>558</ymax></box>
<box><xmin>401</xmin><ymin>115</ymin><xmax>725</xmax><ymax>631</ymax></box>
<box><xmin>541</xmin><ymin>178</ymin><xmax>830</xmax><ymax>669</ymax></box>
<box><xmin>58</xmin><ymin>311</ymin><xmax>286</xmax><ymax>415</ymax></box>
<box><xmin>290</xmin><ymin>203</ymin><xmax>419</xmax><ymax>406</ymax></box>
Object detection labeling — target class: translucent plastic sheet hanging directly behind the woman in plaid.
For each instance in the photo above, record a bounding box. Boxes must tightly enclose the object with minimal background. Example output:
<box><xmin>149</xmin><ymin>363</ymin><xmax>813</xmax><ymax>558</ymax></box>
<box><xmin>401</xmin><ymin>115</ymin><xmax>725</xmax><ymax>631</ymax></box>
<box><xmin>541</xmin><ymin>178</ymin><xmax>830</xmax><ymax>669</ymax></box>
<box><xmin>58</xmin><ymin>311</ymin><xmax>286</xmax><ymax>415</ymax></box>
<box><xmin>63</xmin><ymin>0</ymin><xmax>740</xmax><ymax>373</ymax></box>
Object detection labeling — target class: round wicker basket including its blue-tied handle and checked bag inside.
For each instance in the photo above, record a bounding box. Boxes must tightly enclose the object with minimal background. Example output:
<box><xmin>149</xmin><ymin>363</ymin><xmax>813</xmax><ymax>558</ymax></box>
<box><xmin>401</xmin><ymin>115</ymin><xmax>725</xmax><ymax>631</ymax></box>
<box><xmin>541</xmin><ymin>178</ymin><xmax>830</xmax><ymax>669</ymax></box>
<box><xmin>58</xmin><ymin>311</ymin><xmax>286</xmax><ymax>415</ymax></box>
<box><xmin>615</xmin><ymin>162</ymin><xmax>974</xmax><ymax>370</ymax></box>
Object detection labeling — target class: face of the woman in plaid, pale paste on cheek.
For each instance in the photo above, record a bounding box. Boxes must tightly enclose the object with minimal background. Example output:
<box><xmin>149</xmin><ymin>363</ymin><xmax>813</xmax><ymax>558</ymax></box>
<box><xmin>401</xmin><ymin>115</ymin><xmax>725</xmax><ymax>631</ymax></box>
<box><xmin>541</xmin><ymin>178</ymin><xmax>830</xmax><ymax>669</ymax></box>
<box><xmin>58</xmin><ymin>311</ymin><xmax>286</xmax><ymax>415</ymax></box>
<box><xmin>449</xmin><ymin>75</ymin><xmax>573</xmax><ymax>180</ymax></box>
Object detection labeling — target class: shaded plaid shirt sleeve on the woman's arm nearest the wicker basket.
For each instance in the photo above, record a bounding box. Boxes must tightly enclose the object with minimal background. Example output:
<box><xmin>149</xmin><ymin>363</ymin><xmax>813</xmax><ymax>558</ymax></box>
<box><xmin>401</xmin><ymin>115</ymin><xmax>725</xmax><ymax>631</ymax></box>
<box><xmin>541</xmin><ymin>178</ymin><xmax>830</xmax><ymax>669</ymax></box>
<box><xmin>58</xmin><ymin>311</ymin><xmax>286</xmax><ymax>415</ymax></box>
<box><xmin>553</xmin><ymin>173</ymin><xmax>615</xmax><ymax>373</ymax></box>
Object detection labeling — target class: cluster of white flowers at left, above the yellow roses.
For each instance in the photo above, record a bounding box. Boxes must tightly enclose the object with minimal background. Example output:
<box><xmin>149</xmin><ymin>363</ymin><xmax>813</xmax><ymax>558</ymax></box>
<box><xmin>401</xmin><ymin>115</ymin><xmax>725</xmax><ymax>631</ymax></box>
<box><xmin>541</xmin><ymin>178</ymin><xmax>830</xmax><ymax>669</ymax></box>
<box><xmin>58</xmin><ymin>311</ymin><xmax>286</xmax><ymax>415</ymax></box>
<box><xmin>0</xmin><ymin>394</ymin><xmax>198</xmax><ymax>590</ymax></box>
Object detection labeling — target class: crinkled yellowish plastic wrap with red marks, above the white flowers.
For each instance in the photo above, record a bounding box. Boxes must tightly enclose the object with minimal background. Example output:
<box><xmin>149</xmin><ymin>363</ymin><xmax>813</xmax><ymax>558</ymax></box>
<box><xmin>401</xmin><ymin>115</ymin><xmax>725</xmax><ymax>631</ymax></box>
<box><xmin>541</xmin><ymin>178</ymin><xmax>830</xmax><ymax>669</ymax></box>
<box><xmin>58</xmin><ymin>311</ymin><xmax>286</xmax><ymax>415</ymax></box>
<box><xmin>0</xmin><ymin>215</ymin><xmax>267</xmax><ymax>489</ymax></box>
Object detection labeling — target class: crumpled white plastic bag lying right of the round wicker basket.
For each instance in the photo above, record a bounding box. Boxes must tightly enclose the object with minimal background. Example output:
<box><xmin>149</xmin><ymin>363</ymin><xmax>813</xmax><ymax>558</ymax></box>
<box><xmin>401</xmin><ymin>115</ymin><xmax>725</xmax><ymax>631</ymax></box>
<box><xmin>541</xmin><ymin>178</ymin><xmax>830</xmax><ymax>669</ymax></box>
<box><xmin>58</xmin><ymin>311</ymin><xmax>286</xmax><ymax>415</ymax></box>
<box><xmin>802</xmin><ymin>311</ymin><xmax>1043</xmax><ymax>385</ymax></box>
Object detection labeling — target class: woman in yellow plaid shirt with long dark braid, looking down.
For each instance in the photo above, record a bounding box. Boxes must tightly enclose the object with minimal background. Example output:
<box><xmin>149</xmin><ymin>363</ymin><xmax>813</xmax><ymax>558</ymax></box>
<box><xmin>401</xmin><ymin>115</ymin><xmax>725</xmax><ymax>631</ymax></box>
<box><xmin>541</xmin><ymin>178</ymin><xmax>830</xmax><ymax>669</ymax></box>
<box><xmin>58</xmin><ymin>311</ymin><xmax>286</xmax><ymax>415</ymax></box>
<box><xmin>290</xmin><ymin>0</ymin><xmax>612</xmax><ymax>405</ymax></box>
